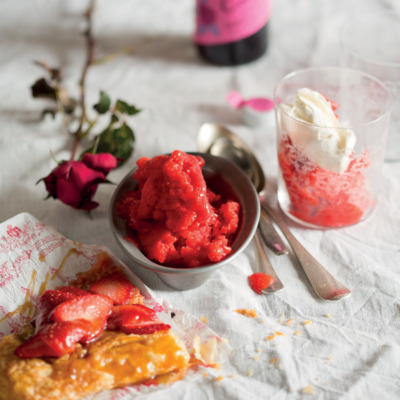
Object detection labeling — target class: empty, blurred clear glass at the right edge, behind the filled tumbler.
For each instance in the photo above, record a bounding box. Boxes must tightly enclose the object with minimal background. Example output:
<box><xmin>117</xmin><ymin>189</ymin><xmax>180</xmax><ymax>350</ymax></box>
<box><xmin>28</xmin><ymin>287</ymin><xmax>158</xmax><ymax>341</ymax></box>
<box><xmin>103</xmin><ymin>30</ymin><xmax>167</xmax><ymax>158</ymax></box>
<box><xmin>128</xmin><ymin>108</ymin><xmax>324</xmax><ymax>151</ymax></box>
<box><xmin>340</xmin><ymin>12</ymin><xmax>400</xmax><ymax>161</ymax></box>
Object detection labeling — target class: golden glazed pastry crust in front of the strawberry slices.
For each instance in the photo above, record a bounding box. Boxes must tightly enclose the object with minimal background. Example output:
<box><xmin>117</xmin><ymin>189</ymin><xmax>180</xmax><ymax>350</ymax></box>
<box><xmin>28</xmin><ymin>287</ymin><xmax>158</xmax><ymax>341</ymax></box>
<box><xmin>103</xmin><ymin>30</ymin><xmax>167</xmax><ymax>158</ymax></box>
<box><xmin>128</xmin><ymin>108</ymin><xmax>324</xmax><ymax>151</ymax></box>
<box><xmin>0</xmin><ymin>327</ymin><xmax>190</xmax><ymax>400</ymax></box>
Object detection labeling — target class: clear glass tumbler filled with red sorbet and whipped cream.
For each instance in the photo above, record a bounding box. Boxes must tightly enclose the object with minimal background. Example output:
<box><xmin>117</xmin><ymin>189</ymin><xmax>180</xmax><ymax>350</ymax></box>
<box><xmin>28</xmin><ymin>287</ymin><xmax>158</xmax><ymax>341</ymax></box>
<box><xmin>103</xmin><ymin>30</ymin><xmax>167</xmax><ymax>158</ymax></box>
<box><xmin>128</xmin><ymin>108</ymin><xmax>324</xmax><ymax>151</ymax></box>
<box><xmin>274</xmin><ymin>67</ymin><xmax>392</xmax><ymax>229</ymax></box>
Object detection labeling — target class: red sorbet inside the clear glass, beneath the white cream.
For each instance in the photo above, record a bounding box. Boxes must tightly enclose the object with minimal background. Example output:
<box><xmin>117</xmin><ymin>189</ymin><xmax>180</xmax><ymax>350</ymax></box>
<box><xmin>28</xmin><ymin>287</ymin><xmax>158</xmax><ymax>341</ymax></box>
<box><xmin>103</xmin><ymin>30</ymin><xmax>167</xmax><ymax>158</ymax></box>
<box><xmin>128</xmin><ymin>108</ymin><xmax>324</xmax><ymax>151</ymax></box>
<box><xmin>278</xmin><ymin>135</ymin><xmax>373</xmax><ymax>227</ymax></box>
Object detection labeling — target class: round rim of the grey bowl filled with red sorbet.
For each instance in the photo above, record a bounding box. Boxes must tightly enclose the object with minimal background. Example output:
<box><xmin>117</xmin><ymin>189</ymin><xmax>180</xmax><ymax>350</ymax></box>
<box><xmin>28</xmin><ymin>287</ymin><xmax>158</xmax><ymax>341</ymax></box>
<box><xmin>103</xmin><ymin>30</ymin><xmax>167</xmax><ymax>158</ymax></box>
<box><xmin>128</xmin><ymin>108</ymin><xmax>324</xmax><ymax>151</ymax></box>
<box><xmin>108</xmin><ymin>152</ymin><xmax>261</xmax><ymax>276</ymax></box>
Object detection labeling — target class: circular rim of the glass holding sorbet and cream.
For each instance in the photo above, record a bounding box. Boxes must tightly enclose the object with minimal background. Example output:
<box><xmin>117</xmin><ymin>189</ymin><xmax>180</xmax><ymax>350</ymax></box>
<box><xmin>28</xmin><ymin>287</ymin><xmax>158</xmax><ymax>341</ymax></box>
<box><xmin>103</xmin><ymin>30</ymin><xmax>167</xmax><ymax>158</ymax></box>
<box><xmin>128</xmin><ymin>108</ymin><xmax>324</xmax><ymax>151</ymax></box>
<box><xmin>274</xmin><ymin>67</ymin><xmax>394</xmax><ymax>130</ymax></box>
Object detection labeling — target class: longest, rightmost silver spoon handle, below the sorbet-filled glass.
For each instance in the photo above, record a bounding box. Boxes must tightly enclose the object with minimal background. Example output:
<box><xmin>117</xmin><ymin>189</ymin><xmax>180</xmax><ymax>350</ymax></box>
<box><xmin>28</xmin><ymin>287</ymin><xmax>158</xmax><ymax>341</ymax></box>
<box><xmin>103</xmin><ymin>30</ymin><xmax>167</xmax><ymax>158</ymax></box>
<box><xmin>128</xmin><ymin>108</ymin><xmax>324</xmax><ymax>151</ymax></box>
<box><xmin>262</xmin><ymin>201</ymin><xmax>351</xmax><ymax>300</ymax></box>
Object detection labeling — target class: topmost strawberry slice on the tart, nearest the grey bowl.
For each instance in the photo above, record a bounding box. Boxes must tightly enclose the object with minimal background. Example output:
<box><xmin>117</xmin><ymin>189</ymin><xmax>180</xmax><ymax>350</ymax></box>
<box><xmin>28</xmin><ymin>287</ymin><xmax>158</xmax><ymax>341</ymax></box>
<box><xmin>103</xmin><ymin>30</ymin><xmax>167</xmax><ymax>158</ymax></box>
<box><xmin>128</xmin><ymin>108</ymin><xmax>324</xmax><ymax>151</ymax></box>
<box><xmin>89</xmin><ymin>271</ymin><xmax>144</xmax><ymax>305</ymax></box>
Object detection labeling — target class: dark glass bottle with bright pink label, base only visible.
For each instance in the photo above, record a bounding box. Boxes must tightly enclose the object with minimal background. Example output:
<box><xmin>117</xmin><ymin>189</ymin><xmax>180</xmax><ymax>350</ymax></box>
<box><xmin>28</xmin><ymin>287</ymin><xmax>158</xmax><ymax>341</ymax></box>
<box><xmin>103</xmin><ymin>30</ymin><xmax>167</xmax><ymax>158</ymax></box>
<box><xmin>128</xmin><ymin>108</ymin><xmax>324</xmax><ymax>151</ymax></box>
<box><xmin>195</xmin><ymin>0</ymin><xmax>272</xmax><ymax>66</ymax></box>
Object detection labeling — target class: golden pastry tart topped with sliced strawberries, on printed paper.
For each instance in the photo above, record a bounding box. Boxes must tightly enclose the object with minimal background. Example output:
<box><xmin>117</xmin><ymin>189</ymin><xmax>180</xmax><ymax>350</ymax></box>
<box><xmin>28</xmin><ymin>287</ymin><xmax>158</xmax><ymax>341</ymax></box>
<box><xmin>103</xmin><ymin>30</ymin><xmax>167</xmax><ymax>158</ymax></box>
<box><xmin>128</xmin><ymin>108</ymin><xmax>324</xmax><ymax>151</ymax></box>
<box><xmin>0</xmin><ymin>253</ymin><xmax>191</xmax><ymax>400</ymax></box>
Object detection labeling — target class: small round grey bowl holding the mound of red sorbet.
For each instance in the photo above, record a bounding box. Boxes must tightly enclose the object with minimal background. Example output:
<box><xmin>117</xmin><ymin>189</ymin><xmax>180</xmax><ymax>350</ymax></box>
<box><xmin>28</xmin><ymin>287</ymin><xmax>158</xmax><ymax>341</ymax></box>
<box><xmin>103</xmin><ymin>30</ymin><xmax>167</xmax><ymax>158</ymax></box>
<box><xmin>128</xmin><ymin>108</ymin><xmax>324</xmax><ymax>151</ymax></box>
<box><xmin>109</xmin><ymin>153</ymin><xmax>260</xmax><ymax>290</ymax></box>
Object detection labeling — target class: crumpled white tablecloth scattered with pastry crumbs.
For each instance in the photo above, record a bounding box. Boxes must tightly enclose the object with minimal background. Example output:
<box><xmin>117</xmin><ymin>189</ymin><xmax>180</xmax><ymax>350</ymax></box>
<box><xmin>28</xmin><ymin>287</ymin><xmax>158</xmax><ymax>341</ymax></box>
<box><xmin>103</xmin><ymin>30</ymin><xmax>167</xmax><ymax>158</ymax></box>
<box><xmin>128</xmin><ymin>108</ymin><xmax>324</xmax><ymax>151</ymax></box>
<box><xmin>0</xmin><ymin>0</ymin><xmax>400</xmax><ymax>400</ymax></box>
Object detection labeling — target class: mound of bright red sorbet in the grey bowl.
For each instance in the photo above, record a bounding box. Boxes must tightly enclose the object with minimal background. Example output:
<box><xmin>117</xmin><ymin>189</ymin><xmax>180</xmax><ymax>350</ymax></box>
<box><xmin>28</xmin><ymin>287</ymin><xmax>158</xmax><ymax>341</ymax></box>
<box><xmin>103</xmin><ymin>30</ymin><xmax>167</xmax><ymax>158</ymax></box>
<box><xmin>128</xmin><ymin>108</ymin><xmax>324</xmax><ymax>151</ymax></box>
<box><xmin>117</xmin><ymin>150</ymin><xmax>240</xmax><ymax>268</ymax></box>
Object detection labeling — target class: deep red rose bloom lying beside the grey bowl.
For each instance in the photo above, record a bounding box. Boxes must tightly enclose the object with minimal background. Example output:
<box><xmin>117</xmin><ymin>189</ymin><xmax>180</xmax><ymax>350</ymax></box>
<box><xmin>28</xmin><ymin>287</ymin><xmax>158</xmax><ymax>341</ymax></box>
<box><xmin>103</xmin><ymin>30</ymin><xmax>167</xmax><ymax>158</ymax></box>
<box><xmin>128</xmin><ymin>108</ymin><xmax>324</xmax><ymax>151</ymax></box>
<box><xmin>42</xmin><ymin>153</ymin><xmax>117</xmax><ymax>210</ymax></box>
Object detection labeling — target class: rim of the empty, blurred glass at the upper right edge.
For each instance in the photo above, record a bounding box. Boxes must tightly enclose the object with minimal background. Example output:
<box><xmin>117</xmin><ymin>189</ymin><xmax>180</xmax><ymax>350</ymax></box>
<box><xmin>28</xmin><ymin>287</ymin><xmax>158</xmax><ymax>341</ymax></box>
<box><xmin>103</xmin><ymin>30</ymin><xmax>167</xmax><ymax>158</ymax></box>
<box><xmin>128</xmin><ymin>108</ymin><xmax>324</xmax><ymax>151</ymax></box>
<box><xmin>340</xmin><ymin>11</ymin><xmax>400</xmax><ymax>68</ymax></box>
